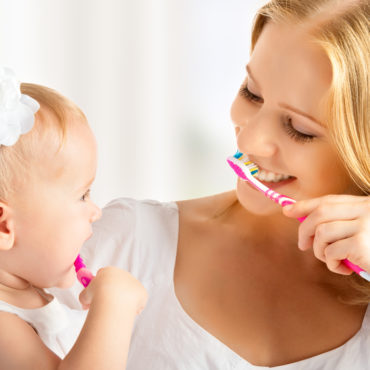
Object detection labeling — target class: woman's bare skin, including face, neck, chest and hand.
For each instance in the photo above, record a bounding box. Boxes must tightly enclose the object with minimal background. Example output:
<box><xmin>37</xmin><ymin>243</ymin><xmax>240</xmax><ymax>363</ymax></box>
<box><xmin>174</xmin><ymin>24</ymin><xmax>370</xmax><ymax>367</ymax></box>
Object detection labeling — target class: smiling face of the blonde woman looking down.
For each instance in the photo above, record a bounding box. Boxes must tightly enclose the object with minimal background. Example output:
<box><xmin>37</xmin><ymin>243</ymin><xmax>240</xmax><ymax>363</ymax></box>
<box><xmin>231</xmin><ymin>23</ymin><xmax>359</xmax><ymax>214</ymax></box>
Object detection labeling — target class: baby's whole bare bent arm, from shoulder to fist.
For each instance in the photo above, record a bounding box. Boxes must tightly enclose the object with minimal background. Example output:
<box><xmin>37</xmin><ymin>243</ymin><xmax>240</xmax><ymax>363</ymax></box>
<box><xmin>0</xmin><ymin>267</ymin><xmax>146</xmax><ymax>370</ymax></box>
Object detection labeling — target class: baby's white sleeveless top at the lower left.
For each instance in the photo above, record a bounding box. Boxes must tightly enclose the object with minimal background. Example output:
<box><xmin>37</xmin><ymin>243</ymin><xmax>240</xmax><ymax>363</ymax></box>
<box><xmin>0</xmin><ymin>297</ymin><xmax>86</xmax><ymax>358</ymax></box>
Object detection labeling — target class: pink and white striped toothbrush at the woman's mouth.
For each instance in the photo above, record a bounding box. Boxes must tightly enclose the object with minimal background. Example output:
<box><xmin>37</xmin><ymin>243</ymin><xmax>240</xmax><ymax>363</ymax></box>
<box><xmin>227</xmin><ymin>151</ymin><xmax>370</xmax><ymax>281</ymax></box>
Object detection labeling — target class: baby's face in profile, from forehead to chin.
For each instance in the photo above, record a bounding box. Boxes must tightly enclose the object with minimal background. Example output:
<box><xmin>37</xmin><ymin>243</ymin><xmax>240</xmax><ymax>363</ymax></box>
<box><xmin>9</xmin><ymin>113</ymin><xmax>100</xmax><ymax>288</ymax></box>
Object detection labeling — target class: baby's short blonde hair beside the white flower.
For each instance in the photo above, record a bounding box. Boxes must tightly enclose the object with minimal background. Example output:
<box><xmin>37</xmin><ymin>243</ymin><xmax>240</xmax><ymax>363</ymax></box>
<box><xmin>0</xmin><ymin>83</ymin><xmax>87</xmax><ymax>201</ymax></box>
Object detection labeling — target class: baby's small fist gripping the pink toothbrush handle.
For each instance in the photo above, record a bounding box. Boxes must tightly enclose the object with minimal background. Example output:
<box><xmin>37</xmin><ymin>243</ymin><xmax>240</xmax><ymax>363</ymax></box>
<box><xmin>80</xmin><ymin>266</ymin><xmax>147</xmax><ymax>314</ymax></box>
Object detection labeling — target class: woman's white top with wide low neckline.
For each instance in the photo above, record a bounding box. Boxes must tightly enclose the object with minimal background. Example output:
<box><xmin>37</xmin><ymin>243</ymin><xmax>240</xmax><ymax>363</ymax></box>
<box><xmin>52</xmin><ymin>199</ymin><xmax>370</xmax><ymax>370</ymax></box>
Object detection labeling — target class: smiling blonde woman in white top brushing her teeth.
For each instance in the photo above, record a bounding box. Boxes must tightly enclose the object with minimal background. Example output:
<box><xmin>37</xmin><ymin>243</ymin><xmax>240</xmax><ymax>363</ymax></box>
<box><xmin>55</xmin><ymin>0</ymin><xmax>370</xmax><ymax>370</ymax></box>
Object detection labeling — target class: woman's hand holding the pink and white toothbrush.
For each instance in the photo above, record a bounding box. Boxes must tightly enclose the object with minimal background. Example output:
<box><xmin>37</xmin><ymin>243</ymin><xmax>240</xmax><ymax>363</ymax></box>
<box><xmin>283</xmin><ymin>195</ymin><xmax>370</xmax><ymax>275</ymax></box>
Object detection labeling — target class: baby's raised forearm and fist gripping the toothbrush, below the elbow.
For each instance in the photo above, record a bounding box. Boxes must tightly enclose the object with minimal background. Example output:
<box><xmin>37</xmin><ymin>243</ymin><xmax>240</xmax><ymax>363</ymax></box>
<box><xmin>60</xmin><ymin>267</ymin><xmax>147</xmax><ymax>370</ymax></box>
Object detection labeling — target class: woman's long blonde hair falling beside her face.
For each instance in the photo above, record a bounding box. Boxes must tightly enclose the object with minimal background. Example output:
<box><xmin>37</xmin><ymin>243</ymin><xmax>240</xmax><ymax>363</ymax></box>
<box><xmin>251</xmin><ymin>0</ymin><xmax>370</xmax><ymax>303</ymax></box>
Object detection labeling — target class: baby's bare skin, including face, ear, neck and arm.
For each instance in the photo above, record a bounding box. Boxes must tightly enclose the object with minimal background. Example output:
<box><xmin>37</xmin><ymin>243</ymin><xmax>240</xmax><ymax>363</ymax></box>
<box><xmin>0</xmin><ymin>108</ymin><xmax>147</xmax><ymax>370</ymax></box>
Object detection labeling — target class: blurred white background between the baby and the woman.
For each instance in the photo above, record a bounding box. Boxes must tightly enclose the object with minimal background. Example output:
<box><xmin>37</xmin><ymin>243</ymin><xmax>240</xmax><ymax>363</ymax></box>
<box><xmin>0</xmin><ymin>0</ymin><xmax>266</xmax><ymax>206</ymax></box>
